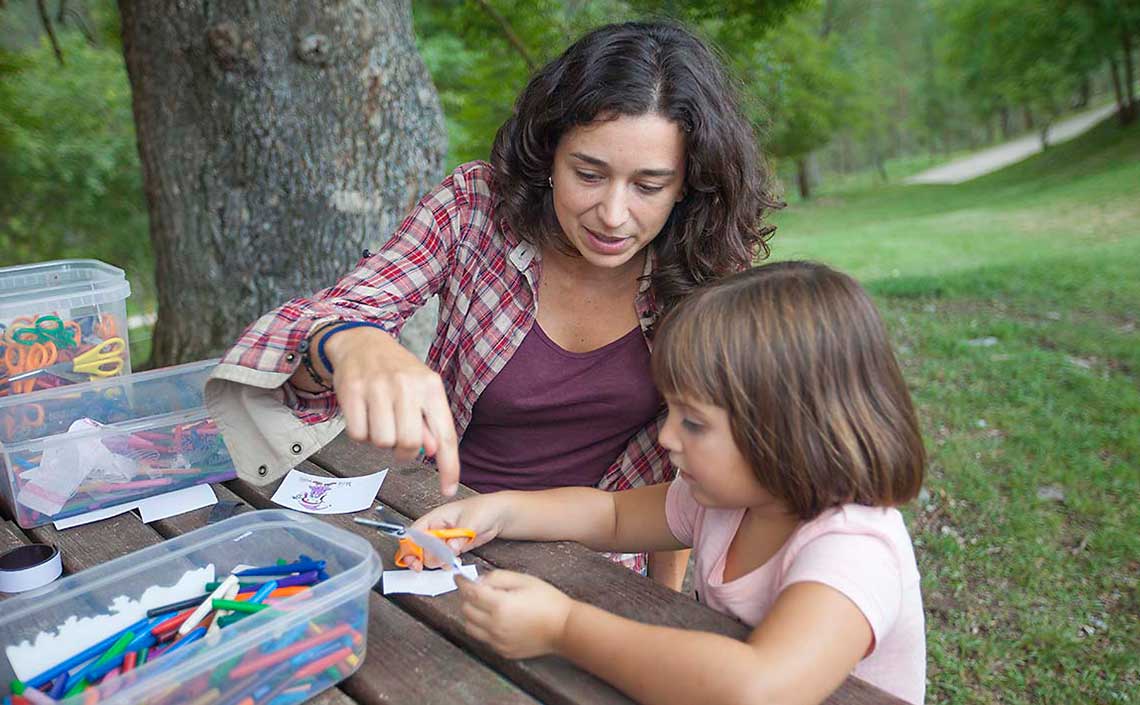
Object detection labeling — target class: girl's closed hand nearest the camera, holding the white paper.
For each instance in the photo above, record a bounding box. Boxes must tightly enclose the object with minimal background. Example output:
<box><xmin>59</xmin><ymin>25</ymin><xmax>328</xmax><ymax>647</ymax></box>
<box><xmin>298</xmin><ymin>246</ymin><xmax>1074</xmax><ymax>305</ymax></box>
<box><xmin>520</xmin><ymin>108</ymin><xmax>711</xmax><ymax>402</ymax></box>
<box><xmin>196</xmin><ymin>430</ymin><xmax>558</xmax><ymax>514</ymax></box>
<box><xmin>455</xmin><ymin>570</ymin><xmax>573</xmax><ymax>658</ymax></box>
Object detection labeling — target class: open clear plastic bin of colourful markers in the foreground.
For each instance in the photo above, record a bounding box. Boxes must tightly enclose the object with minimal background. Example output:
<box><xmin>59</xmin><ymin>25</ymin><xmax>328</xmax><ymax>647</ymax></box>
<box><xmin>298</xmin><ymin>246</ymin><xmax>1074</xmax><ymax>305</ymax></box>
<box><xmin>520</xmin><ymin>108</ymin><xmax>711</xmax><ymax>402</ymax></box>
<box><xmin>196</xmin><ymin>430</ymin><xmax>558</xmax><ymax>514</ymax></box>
<box><xmin>0</xmin><ymin>510</ymin><xmax>381</xmax><ymax>705</ymax></box>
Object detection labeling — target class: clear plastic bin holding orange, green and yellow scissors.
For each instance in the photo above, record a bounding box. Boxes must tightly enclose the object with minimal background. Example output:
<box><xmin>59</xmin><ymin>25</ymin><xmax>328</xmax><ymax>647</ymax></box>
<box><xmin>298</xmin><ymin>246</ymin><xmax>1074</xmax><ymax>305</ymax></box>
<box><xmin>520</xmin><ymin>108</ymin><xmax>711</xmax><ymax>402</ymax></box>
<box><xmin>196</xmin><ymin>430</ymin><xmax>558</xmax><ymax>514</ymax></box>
<box><xmin>0</xmin><ymin>259</ymin><xmax>131</xmax><ymax>397</ymax></box>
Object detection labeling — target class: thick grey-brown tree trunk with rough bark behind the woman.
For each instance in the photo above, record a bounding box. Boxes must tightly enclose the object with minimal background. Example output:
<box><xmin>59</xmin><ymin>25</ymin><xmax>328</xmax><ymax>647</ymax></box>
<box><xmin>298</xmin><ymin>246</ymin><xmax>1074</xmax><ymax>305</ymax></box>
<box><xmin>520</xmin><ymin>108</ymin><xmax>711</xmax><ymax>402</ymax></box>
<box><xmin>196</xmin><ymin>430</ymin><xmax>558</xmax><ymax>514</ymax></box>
<box><xmin>119</xmin><ymin>0</ymin><xmax>447</xmax><ymax>365</ymax></box>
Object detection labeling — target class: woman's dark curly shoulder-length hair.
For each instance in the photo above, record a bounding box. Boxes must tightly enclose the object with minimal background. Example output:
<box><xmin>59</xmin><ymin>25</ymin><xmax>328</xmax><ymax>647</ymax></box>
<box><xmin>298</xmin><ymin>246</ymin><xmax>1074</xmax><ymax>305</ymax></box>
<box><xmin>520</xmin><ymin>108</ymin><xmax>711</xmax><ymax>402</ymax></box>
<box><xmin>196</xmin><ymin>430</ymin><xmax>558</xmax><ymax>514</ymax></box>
<box><xmin>491</xmin><ymin>22</ymin><xmax>783</xmax><ymax>313</ymax></box>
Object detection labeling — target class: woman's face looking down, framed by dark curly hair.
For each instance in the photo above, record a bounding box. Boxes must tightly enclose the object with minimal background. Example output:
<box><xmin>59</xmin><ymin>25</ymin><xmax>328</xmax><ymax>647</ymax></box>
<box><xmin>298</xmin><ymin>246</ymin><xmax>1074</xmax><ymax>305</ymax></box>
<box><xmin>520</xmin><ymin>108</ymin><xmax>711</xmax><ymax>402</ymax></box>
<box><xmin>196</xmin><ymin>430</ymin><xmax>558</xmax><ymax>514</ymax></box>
<box><xmin>551</xmin><ymin>114</ymin><xmax>685</xmax><ymax>269</ymax></box>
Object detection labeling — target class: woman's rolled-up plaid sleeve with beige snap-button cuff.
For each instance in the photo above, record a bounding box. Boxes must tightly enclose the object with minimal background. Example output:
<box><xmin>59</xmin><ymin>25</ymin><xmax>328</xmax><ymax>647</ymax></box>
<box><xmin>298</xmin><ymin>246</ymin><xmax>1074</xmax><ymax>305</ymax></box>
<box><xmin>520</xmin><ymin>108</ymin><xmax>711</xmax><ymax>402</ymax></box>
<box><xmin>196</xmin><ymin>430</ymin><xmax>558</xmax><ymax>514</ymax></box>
<box><xmin>205</xmin><ymin>167</ymin><xmax>470</xmax><ymax>485</ymax></box>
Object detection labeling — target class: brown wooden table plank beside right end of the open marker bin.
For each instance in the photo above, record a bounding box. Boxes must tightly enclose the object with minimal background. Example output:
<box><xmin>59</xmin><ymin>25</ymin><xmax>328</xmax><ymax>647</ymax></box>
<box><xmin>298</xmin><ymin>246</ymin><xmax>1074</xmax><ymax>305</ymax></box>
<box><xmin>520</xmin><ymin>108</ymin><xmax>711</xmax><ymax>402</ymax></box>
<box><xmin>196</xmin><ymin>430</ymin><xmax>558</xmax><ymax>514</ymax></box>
<box><xmin>152</xmin><ymin>485</ymin><xmax>535</xmax><ymax>705</ymax></box>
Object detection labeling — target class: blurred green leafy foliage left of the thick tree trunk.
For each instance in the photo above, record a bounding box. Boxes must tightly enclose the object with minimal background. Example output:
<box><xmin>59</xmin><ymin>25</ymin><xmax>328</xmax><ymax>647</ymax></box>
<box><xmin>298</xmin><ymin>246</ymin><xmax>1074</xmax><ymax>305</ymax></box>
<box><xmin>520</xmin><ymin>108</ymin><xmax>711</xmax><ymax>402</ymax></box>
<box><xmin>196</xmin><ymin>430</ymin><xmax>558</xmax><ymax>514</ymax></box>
<box><xmin>0</xmin><ymin>32</ymin><xmax>152</xmax><ymax>290</ymax></box>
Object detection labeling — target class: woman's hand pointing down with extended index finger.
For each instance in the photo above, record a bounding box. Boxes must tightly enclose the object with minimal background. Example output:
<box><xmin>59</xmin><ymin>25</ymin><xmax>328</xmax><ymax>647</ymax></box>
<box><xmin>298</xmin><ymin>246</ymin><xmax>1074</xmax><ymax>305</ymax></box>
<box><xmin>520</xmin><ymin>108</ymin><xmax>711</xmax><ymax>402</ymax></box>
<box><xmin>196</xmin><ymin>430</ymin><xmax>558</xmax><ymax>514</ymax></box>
<box><xmin>314</xmin><ymin>326</ymin><xmax>459</xmax><ymax>496</ymax></box>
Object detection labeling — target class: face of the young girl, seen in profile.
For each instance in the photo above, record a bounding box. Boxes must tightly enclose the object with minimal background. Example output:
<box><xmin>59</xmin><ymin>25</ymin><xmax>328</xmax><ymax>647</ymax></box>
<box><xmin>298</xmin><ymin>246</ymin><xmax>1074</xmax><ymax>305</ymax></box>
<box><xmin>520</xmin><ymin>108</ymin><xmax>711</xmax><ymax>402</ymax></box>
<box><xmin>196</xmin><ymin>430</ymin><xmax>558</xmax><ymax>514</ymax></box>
<box><xmin>658</xmin><ymin>397</ymin><xmax>779</xmax><ymax>509</ymax></box>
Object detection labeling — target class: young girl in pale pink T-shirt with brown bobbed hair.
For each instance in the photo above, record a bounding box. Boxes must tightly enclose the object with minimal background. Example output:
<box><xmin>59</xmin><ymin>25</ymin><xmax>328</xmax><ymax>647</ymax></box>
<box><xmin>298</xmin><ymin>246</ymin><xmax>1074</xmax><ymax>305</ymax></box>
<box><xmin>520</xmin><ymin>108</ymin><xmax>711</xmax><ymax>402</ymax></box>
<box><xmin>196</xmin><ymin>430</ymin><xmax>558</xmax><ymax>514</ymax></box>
<box><xmin>417</xmin><ymin>262</ymin><xmax>926</xmax><ymax>704</ymax></box>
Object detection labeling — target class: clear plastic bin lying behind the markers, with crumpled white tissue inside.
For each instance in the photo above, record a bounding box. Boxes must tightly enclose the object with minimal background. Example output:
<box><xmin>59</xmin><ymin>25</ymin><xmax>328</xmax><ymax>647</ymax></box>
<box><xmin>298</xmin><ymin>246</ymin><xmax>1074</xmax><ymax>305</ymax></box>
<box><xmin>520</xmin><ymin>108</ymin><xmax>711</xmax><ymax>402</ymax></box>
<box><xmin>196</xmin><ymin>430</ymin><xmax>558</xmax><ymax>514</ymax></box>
<box><xmin>0</xmin><ymin>360</ymin><xmax>235</xmax><ymax>528</ymax></box>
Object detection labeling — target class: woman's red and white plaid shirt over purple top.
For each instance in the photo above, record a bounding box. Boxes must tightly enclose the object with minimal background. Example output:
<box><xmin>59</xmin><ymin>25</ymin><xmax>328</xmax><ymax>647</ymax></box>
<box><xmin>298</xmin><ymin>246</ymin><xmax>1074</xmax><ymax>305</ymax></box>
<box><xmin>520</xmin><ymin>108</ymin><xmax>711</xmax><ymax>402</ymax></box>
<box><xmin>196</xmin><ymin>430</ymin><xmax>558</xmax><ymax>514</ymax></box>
<box><xmin>222</xmin><ymin>162</ymin><xmax>673</xmax><ymax>572</ymax></box>
